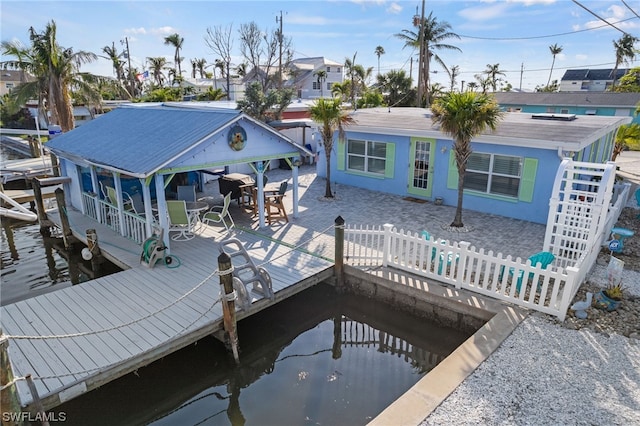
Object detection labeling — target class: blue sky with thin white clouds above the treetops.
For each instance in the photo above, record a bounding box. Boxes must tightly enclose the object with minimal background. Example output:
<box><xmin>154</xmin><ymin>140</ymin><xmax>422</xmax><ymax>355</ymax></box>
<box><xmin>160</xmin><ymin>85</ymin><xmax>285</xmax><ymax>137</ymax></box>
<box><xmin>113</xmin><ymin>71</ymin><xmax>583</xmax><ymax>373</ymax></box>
<box><xmin>0</xmin><ymin>0</ymin><xmax>640</xmax><ymax>90</ymax></box>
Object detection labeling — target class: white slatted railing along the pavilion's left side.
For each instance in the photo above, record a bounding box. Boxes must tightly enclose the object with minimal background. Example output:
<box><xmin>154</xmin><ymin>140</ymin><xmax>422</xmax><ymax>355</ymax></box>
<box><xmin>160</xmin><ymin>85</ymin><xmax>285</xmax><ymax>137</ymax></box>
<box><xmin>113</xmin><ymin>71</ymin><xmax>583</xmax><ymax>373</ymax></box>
<box><xmin>82</xmin><ymin>192</ymin><xmax>146</xmax><ymax>244</ymax></box>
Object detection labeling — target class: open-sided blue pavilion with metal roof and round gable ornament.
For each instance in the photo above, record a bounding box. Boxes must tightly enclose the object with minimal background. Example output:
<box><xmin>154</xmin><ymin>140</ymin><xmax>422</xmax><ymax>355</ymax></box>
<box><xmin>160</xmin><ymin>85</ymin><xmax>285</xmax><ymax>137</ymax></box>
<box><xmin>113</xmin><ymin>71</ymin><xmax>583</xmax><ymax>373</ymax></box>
<box><xmin>47</xmin><ymin>103</ymin><xmax>311</xmax><ymax>247</ymax></box>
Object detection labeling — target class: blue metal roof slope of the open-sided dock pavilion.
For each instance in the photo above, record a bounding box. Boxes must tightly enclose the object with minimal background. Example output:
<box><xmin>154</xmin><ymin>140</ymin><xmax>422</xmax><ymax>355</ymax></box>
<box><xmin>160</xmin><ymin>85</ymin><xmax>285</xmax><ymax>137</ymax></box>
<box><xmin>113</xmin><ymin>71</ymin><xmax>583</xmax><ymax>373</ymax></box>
<box><xmin>47</xmin><ymin>105</ymin><xmax>245</xmax><ymax>176</ymax></box>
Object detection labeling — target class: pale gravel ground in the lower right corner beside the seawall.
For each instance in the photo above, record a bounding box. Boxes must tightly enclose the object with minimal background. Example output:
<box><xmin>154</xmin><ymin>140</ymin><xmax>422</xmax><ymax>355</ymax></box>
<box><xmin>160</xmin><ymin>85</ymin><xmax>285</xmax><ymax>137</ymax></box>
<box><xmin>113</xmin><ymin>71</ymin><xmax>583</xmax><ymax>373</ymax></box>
<box><xmin>422</xmin><ymin>200</ymin><xmax>640</xmax><ymax>426</ymax></box>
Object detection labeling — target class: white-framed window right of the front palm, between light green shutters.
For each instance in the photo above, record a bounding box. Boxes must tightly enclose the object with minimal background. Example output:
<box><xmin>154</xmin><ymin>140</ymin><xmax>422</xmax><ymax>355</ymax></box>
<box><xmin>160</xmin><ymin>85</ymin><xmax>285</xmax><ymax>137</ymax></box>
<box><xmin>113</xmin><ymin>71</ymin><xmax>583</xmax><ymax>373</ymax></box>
<box><xmin>464</xmin><ymin>152</ymin><xmax>522</xmax><ymax>197</ymax></box>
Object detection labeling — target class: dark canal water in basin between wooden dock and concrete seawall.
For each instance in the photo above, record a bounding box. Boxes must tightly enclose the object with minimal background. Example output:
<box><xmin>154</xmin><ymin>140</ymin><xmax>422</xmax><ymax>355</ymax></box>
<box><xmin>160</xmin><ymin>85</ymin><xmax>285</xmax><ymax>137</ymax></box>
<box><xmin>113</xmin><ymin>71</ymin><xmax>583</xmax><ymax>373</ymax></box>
<box><xmin>53</xmin><ymin>284</ymin><xmax>469</xmax><ymax>426</ymax></box>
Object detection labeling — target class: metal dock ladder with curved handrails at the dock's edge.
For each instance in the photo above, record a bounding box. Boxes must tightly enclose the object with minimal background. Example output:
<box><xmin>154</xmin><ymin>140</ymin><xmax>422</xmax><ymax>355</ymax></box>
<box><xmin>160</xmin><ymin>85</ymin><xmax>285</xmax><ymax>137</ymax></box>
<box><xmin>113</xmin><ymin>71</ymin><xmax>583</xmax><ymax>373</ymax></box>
<box><xmin>220</xmin><ymin>238</ymin><xmax>275</xmax><ymax>308</ymax></box>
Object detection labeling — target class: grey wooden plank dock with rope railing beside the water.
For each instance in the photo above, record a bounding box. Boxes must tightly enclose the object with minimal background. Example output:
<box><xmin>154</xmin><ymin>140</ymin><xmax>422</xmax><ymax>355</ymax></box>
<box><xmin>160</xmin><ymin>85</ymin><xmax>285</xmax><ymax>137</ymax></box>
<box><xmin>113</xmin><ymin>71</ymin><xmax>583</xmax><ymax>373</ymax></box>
<box><xmin>0</xmin><ymin>211</ymin><xmax>333</xmax><ymax>410</ymax></box>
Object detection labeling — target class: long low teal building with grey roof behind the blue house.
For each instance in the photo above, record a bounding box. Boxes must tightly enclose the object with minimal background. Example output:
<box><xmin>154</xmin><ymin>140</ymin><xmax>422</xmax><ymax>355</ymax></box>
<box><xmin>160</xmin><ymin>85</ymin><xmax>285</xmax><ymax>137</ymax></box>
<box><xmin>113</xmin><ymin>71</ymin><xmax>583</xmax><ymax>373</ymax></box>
<box><xmin>493</xmin><ymin>92</ymin><xmax>640</xmax><ymax>123</ymax></box>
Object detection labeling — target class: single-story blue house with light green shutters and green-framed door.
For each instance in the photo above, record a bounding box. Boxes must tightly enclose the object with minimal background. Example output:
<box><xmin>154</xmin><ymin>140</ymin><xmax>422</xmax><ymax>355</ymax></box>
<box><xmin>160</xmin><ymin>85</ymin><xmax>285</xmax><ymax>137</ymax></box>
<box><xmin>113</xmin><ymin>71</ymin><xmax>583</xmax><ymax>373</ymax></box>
<box><xmin>317</xmin><ymin>108</ymin><xmax>631</xmax><ymax>223</ymax></box>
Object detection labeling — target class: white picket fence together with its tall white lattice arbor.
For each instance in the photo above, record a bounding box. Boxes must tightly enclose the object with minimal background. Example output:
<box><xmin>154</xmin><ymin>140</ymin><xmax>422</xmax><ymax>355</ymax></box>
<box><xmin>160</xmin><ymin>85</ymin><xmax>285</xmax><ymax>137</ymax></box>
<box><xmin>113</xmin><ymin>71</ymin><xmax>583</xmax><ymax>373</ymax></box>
<box><xmin>344</xmin><ymin>159</ymin><xmax>630</xmax><ymax>321</ymax></box>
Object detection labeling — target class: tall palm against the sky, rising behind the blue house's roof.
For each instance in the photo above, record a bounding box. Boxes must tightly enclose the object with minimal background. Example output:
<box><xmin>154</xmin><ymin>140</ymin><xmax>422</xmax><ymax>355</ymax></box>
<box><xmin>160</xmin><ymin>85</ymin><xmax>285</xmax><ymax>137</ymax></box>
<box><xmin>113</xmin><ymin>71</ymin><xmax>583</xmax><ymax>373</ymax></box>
<box><xmin>394</xmin><ymin>12</ymin><xmax>462</xmax><ymax>106</ymax></box>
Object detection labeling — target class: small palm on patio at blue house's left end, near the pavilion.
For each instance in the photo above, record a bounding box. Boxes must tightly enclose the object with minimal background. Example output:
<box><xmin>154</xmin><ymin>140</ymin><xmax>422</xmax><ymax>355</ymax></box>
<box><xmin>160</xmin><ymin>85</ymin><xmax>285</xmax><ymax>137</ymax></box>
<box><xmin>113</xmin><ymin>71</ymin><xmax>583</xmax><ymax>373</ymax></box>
<box><xmin>309</xmin><ymin>98</ymin><xmax>354</xmax><ymax>198</ymax></box>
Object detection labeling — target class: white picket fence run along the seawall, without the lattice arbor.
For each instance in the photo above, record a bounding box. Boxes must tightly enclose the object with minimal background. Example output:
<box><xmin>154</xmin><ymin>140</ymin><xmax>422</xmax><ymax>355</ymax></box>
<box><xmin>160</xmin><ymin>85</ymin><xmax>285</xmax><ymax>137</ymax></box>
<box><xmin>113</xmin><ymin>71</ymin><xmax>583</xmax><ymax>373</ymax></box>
<box><xmin>344</xmin><ymin>224</ymin><xmax>579</xmax><ymax>320</ymax></box>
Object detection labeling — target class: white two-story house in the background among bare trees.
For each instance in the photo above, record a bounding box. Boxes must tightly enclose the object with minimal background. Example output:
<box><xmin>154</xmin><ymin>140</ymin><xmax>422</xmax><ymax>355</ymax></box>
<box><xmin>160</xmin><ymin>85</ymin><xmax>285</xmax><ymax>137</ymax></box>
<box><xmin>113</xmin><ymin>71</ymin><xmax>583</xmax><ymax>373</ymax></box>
<box><xmin>285</xmin><ymin>56</ymin><xmax>343</xmax><ymax>99</ymax></box>
